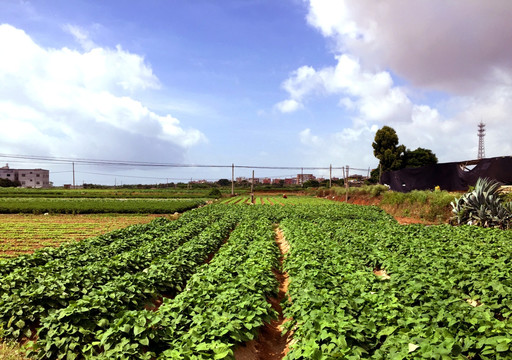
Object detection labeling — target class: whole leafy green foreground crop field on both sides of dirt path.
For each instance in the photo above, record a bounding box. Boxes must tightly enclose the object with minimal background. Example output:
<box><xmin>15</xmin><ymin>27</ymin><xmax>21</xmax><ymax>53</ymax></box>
<box><xmin>0</xmin><ymin>204</ymin><xmax>512</xmax><ymax>360</ymax></box>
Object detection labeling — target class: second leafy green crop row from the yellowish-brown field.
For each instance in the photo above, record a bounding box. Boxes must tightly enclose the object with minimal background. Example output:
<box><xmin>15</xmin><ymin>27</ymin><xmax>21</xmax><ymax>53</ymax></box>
<box><xmin>0</xmin><ymin>215</ymin><xmax>214</xmax><ymax>338</ymax></box>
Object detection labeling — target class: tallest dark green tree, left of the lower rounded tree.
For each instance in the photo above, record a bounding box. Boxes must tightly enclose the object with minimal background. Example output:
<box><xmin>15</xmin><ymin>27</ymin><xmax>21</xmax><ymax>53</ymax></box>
<box><xmin>372</xmin><ymin>126</ymin><xmax>405</xmax><ymax>171</ymax></box>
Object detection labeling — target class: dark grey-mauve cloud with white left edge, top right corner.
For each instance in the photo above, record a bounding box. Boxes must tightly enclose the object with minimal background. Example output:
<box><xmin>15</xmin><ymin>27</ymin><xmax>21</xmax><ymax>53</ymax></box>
<box><xmin>307</xmin><ymin>0</ymin><xmax>512</xmax><ymax>94</ymax></box>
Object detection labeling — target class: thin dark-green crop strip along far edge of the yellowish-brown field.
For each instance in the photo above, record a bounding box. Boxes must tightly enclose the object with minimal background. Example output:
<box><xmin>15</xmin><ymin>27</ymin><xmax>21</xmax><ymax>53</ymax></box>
<box><xmin>0</xmin><ymin>198</ymin><xmax>205</xmax><ymax>214</ymax></box>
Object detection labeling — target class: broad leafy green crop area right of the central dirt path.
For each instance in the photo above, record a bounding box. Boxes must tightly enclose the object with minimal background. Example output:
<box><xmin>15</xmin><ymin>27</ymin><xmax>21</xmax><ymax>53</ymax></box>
<box><xmin>280</xmin><ymin>214</ymin><xmax>512</xmax><ymax>359</ymax></box>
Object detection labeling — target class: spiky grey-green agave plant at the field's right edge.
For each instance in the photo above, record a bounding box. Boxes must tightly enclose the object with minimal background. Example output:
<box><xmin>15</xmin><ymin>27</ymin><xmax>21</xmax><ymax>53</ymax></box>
<box><xmin>451</xmin><ymin>178</ymin><xmax>512</xmax><ymax>229</ymax></box>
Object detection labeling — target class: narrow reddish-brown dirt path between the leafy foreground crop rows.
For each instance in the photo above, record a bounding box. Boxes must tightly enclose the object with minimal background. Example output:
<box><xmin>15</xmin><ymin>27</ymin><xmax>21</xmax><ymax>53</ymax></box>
<box><xmin>234</xmin><ymin>229</ymin><xmax>291</xmax><ymax>360</ymax></box>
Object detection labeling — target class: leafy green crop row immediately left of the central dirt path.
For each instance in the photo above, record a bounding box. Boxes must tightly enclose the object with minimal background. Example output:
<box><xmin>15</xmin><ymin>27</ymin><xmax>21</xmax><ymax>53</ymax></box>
<box><xmin>89</xmin><ymin>210</ymin><xmax>279</xmax><ymax>359</ymax></box>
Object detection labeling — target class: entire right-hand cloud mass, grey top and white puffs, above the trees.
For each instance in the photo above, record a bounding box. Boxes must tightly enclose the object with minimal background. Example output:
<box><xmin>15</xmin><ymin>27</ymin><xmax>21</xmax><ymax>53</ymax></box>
<box><xmin>276</xmin><ymin>0</ymin><xmax>512</xmax><ymax>164</ymax></box>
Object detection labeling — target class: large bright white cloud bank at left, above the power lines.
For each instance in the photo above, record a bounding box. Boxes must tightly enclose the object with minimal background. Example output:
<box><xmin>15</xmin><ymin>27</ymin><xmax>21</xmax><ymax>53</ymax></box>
<box><xmin>0</xmin><ymin>24</ymin><xmax>206</xmax><ymax>162</ymax></box>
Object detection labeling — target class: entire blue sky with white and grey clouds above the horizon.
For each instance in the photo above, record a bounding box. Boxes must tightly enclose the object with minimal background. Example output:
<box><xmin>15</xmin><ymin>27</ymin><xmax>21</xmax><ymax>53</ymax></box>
<box><xmin>0</xmin><ymin>0</ymin><xmax>512</xmax><ymax>185</ymax></box>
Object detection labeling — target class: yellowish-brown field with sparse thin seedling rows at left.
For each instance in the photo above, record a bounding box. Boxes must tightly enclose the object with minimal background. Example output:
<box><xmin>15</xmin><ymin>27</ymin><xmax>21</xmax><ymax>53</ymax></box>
<box><xmin>0</xmin><ymin>214</ymin><xmax>164</xmax><ymax>259</ymax></box>
